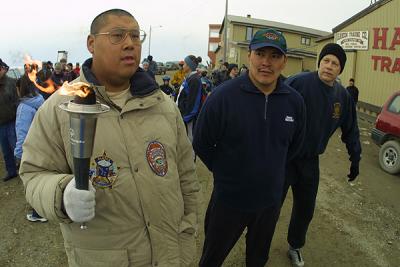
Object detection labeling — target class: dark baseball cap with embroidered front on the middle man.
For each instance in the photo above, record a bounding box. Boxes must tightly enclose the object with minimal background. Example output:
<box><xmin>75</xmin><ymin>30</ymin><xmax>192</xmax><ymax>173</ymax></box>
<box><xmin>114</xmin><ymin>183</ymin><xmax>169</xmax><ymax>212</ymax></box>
<box><xmin>249</xmin><ymin>28</ymin><xmax>287</xmax><ymax>54</ymax></box>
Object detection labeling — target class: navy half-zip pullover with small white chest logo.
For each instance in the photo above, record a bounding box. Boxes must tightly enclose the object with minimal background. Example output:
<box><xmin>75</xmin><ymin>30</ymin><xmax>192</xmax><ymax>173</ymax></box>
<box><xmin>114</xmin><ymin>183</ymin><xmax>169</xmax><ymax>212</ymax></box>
<box><xmin>193</xmin><ymin>74</ymin><xmax>305</xmax><ymax>211</ymax></box>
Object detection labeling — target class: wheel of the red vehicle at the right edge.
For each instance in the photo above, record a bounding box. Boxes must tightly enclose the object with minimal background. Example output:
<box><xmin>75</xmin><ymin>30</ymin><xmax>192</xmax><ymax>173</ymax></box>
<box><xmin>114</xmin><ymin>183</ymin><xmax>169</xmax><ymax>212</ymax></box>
<box><xmin>379</xmin><ymin>140</ymin><xmax>400</xmax><ymax>174</ymax></box>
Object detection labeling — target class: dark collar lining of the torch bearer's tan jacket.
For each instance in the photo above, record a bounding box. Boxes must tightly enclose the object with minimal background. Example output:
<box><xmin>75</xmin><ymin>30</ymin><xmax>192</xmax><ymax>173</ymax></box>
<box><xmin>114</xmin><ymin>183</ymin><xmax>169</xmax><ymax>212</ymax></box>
<box><xmin>81</xmin><ymin>58</ymin><xmax>158</xmax><ymax>97</ymax></box>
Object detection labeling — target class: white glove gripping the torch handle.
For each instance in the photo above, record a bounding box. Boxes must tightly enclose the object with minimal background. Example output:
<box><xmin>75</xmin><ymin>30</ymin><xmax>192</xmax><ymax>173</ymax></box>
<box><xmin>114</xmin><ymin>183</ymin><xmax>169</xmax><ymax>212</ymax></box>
<box><xmin>63</xmin><ymin>179</ymin><xmax>96</xmax><ymax>223</ymax></box>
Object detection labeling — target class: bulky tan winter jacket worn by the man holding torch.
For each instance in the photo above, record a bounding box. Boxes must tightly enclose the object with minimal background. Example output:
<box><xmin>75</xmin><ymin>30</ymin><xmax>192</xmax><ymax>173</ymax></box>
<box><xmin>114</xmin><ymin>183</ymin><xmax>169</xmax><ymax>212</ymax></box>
<box><xmin>20</xmin><ymin>60</ymin><xmax>199</xmax><ymax>267</ymax></box>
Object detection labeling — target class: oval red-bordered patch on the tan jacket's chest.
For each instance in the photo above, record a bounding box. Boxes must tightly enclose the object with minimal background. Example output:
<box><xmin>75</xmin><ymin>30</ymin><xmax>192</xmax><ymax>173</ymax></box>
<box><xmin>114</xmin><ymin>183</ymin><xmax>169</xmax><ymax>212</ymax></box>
<box><xmin>146</xmin><ymin>141</ymin><xmax>168</xmax><ymax>176</ymax></box>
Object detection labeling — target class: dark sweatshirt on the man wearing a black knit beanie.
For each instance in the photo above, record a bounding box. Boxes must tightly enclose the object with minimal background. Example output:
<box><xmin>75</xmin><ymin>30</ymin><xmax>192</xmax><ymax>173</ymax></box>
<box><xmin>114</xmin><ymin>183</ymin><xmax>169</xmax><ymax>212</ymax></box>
<box><xmin>285</xmin><ymin>72</ymin><xmax>361</xmax><ymax>162</ymax></box>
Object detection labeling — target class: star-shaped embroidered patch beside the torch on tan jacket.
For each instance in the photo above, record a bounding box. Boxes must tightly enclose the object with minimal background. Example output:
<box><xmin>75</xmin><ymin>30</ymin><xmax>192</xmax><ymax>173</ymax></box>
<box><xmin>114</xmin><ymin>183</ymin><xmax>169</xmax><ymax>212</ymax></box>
<box><xmin>89</xmin><ymin>151</ymin><xmax>117</xmax><ymax>189</ymax></box>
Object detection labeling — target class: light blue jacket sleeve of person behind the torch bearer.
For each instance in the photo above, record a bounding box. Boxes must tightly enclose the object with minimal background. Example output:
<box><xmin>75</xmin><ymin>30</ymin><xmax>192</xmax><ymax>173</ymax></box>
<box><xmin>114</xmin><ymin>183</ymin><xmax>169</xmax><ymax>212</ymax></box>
<box><xmin>14</xmin><ymin>103</ymin><xmax>36</xmax><ymax>159</ymax></box>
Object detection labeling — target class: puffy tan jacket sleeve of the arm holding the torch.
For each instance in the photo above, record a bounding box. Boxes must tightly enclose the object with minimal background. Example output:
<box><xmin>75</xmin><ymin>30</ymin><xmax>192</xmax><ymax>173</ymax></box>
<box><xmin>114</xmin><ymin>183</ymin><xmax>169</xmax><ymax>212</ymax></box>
<box><xmin>20</xmin><ymin>95</ymin><xmax>73</xmax><ymax>222</ymax></box>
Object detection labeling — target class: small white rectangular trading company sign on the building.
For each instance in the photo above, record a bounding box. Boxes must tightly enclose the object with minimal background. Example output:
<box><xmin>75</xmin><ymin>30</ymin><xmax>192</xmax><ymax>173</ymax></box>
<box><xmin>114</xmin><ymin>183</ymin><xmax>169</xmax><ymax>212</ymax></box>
<box><xmin>335</xmin><ymin>31</ymin><xmax>368</xmax><ymax>50</ymax></box>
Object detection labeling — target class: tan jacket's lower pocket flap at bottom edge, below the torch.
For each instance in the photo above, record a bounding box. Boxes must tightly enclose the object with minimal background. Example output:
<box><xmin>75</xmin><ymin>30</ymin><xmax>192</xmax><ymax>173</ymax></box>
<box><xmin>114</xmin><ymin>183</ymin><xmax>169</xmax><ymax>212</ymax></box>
<box><xmin>68</xmin><ymin>248</ymin><xmax>129</xmax><ymax>267</ymax></box>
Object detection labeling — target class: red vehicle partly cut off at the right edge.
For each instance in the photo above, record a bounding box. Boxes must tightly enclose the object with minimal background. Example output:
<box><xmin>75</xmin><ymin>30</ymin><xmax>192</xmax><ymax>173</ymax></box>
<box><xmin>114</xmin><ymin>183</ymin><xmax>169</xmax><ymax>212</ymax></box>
<box><xmin>371</xmin><ymin>91</ymin><xmax>400</xmax><ymax>174</ymax></box>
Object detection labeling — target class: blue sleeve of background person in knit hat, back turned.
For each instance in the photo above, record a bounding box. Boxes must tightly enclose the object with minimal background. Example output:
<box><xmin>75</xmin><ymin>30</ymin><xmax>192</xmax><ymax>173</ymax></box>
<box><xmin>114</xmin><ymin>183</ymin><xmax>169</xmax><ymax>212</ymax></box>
<box><xmin>183</xmin><ymin>78</ymin><xmax>201</xmax><ymax>122</ymax></box>
